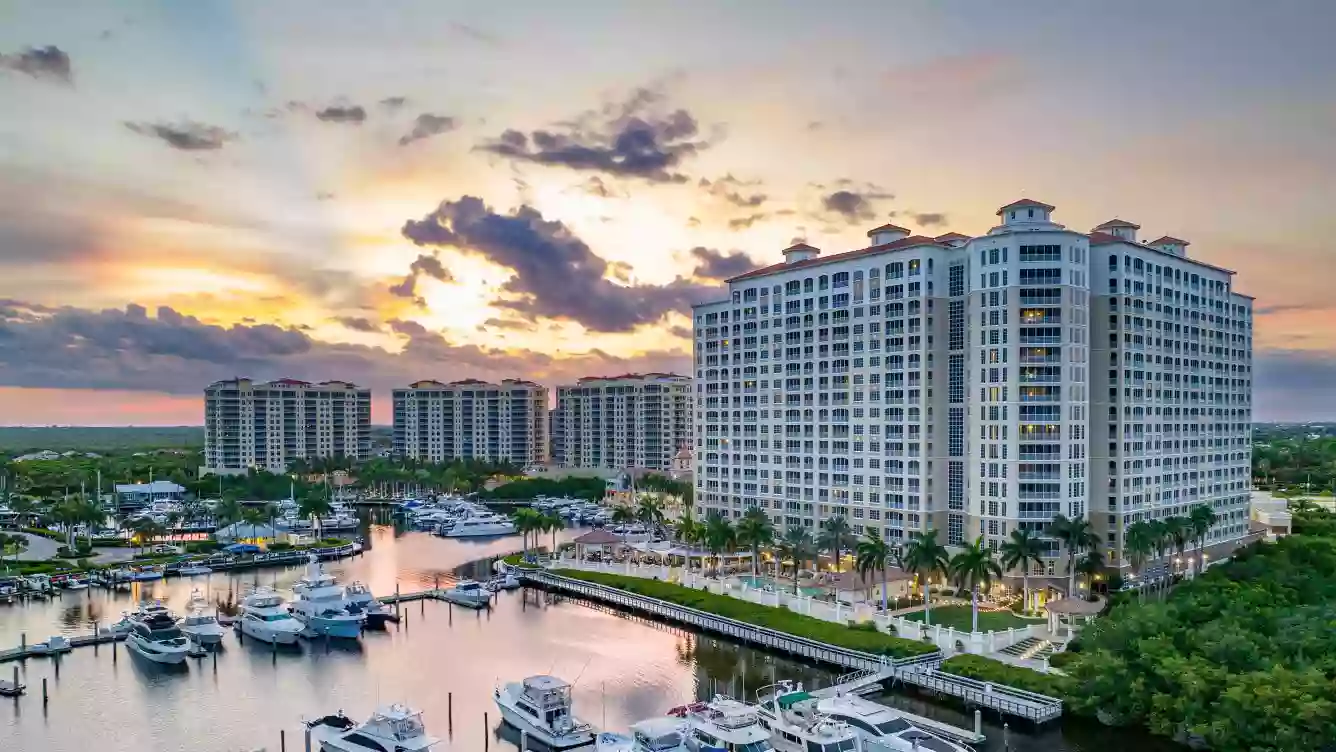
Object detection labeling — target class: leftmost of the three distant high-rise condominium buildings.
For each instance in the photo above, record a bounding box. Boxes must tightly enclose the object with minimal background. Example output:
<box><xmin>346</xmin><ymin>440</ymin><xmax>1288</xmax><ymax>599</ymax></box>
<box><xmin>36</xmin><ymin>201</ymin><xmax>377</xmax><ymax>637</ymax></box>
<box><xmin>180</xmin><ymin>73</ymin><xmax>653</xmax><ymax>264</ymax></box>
<box><xmin>197</xmin><ymin>378</ymin><xmax>371</xmax><ymax>476</ymax></box>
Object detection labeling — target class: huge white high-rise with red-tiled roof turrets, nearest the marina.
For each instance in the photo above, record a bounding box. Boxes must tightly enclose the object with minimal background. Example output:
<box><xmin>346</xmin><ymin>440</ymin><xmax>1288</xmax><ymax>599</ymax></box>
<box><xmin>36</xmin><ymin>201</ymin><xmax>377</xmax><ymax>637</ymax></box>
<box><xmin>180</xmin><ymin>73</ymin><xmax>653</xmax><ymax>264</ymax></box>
<box><xmin>693</xmin><ymin>200</ymin><xmax>1252</xmax><ymax>574</ymax></box>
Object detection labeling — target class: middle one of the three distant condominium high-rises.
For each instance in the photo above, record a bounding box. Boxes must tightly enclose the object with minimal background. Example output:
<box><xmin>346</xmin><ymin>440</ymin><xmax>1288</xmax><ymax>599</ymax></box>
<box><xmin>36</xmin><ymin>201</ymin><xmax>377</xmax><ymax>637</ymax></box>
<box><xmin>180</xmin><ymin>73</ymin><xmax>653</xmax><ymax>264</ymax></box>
<box><xmin>394</xmin><ymin>379</ymin><xmax>548</xmax><ymax>466</ymax></box>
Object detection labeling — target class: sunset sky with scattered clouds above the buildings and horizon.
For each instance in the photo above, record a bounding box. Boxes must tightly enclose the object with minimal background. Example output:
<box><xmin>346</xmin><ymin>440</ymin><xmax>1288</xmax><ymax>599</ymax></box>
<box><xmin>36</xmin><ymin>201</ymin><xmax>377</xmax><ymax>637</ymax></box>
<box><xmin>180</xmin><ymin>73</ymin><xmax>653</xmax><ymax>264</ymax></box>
<box><xmin>0</xmin><ymin>0</ymin><xmax>1336</xmax><ymax>425</ymax></box>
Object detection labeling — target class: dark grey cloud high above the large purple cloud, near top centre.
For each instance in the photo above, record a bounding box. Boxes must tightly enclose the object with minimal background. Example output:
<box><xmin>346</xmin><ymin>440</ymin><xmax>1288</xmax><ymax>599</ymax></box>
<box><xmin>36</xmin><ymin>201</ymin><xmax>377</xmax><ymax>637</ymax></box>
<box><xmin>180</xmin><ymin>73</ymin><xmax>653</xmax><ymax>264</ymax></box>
<box><xmin>478</xmin><ymin>88</ymin><xmax>709</xmax><ymax>183</ymax></box>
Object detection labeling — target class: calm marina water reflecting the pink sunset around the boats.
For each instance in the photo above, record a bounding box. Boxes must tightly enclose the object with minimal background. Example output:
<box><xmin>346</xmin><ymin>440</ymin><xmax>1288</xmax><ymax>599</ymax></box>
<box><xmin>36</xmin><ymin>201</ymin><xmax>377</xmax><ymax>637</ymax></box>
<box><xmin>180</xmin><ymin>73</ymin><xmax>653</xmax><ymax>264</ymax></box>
<box><xmin>0</xmin><ymin>526</ymin><xmax>1177</xmax><ymax>752</ymax></box>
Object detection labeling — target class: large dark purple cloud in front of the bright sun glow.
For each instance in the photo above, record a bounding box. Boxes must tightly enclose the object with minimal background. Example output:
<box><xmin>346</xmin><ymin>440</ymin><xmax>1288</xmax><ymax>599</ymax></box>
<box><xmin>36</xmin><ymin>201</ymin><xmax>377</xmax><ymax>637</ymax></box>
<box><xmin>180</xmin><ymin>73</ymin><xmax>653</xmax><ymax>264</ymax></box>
<box><xmin>403</xmin><ymin>196</ymin><xmax>716</xmax><ymax>331</ymax></box>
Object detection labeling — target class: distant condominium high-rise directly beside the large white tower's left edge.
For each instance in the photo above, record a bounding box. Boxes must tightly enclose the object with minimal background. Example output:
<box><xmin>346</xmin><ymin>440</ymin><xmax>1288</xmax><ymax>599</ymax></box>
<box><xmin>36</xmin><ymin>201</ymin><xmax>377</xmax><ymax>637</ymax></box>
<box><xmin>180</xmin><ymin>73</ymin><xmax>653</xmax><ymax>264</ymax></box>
<box><xmin>552</xmin><ymin>374</ymin><xmax>692</xmax><ymax>473</ymax></box>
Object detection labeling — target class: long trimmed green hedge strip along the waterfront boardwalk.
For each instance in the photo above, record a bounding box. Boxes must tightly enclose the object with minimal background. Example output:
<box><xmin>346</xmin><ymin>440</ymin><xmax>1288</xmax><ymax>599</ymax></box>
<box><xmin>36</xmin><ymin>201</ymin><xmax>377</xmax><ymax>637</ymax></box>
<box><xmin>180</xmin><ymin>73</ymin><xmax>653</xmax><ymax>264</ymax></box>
<box><xmin>553</xmin><ymin>569</ymin><xmax>938</xmax><ymax>659</ymax></box>
